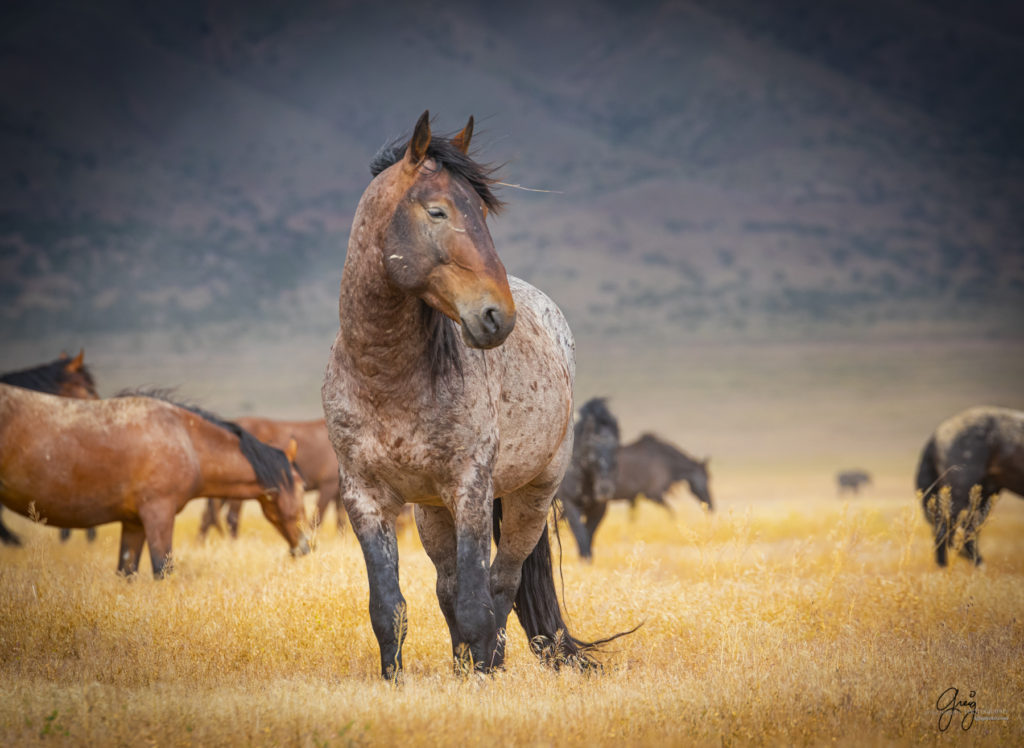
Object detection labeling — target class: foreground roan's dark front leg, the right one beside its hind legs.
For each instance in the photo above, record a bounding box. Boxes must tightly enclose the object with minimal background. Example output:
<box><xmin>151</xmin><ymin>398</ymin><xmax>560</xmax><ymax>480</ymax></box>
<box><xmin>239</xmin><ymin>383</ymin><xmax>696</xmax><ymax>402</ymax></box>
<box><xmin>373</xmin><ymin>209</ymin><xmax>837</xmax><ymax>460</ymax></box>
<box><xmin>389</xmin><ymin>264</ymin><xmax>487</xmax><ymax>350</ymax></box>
<box><xmin>455</xmin><ymin>464</ymin><xmax>501</xmax><ymax>671</ymax></box>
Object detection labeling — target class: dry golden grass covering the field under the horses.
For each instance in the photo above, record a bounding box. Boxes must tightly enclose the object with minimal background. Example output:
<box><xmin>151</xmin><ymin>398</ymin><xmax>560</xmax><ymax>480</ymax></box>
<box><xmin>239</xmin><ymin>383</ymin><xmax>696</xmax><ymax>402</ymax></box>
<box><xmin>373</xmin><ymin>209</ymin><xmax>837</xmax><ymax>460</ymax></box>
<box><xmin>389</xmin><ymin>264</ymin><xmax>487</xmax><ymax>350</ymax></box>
<box><xmin>0</xmin><ymin>481</ymin><xmax>1024</xmax><ymax>746</ymax></box>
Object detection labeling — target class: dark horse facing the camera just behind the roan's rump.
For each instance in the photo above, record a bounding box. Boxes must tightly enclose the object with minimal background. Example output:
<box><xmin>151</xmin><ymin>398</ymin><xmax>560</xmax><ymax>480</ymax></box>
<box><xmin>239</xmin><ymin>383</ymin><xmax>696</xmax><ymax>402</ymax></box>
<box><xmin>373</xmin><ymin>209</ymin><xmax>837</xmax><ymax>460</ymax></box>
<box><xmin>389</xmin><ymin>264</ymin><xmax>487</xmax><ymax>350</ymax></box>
<box><xmin>558</xmin><ymin>398</ymin><xmax>618</xmax><ymax>559</ymax></box>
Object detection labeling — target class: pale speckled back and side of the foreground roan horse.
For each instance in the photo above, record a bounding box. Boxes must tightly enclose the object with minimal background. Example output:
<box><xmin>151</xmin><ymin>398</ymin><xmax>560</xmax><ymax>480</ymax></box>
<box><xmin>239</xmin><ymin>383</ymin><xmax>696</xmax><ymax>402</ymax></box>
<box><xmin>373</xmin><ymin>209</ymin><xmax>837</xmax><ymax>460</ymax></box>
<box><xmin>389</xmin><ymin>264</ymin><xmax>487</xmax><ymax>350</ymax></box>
<box><xmin>495</xmin><ymin>277</ymin><xmax>575</xmax><ymax>495</ymax></box>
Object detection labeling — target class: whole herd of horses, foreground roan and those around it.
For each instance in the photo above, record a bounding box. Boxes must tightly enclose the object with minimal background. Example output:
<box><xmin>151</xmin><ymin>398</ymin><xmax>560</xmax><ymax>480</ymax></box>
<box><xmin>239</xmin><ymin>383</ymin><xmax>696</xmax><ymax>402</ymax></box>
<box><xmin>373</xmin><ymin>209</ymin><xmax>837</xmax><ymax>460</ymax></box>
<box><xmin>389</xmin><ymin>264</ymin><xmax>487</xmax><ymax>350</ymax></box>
<box><xmin>0</xmin><ymin>112</ymin><xmax>1024</xmax><ymax>678</ymax></box>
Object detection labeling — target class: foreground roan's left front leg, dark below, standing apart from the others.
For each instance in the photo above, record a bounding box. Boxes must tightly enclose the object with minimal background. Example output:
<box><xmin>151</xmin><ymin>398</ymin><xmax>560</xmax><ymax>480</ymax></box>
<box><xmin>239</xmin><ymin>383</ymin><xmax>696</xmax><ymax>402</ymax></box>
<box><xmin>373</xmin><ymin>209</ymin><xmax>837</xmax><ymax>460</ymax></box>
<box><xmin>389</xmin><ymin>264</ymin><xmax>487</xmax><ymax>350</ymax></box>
<box><xmin>342</xmin><ymin>477</ymin><xmax>409</xmax><ymax>678</ymax></box>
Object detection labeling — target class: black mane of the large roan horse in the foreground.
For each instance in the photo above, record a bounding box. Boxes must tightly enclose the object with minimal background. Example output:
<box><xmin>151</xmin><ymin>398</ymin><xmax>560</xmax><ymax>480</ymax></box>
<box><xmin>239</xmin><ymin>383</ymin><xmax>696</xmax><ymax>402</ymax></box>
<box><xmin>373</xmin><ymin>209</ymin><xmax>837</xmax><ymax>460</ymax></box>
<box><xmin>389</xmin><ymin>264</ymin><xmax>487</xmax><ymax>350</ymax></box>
<box><xmin>370</xmin><ymin>126</ymin><xmax>504</xmax><ymax>390</ymax></box>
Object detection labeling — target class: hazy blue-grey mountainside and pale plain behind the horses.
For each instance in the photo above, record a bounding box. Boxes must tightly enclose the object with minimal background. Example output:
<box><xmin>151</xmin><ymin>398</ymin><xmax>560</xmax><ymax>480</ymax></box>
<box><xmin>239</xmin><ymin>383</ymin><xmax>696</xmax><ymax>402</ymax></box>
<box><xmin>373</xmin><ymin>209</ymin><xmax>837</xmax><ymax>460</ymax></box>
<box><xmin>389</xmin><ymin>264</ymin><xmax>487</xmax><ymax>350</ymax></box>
<box><xmin>0</xmin><ymin>0</ymin><xmax>1024</xmax><ymax>492</ymax></box>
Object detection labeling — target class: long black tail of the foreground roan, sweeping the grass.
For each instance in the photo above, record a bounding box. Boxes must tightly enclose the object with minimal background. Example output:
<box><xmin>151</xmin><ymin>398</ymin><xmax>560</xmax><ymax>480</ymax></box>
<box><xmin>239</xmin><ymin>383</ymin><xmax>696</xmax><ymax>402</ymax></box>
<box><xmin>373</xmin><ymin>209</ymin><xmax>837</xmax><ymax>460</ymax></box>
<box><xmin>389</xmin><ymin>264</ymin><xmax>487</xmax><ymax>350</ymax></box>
<box><xmin>494</xmin><ymin>498</ymin><xmax>640</xmax><ymax>669</ymax></box>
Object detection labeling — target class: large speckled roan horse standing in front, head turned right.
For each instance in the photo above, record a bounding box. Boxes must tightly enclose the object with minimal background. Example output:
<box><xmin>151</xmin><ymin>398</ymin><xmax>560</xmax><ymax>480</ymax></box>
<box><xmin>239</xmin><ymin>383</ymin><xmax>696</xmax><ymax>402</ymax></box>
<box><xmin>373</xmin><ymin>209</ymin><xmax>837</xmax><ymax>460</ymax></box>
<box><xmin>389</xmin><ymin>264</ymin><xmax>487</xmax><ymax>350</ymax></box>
<box><xmin>323</xmin><ymin>112</ymin><xmax>622</xmax><ymax>677</ymax></box>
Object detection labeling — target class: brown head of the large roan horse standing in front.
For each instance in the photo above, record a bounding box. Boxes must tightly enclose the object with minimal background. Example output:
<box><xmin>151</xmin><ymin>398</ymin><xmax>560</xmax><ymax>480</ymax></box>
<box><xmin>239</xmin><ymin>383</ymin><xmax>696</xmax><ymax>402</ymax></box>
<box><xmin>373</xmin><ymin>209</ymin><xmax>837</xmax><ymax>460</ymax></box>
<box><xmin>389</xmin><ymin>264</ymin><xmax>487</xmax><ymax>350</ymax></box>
<box><xmin>382</xmin><ymin>112</ymin><xmax>516</xmax><ymax>348</ymax></box>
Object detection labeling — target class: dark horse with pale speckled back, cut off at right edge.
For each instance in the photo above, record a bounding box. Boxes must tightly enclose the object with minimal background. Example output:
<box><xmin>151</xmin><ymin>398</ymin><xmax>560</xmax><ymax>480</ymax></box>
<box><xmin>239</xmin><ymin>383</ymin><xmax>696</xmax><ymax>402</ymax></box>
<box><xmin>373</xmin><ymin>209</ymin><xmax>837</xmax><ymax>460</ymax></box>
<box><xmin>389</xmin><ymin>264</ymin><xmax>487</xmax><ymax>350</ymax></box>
<box><xmin>916</xmin><ymin>407</ymin><xmax>1024</xmax><ymax>567</ymax></box>
